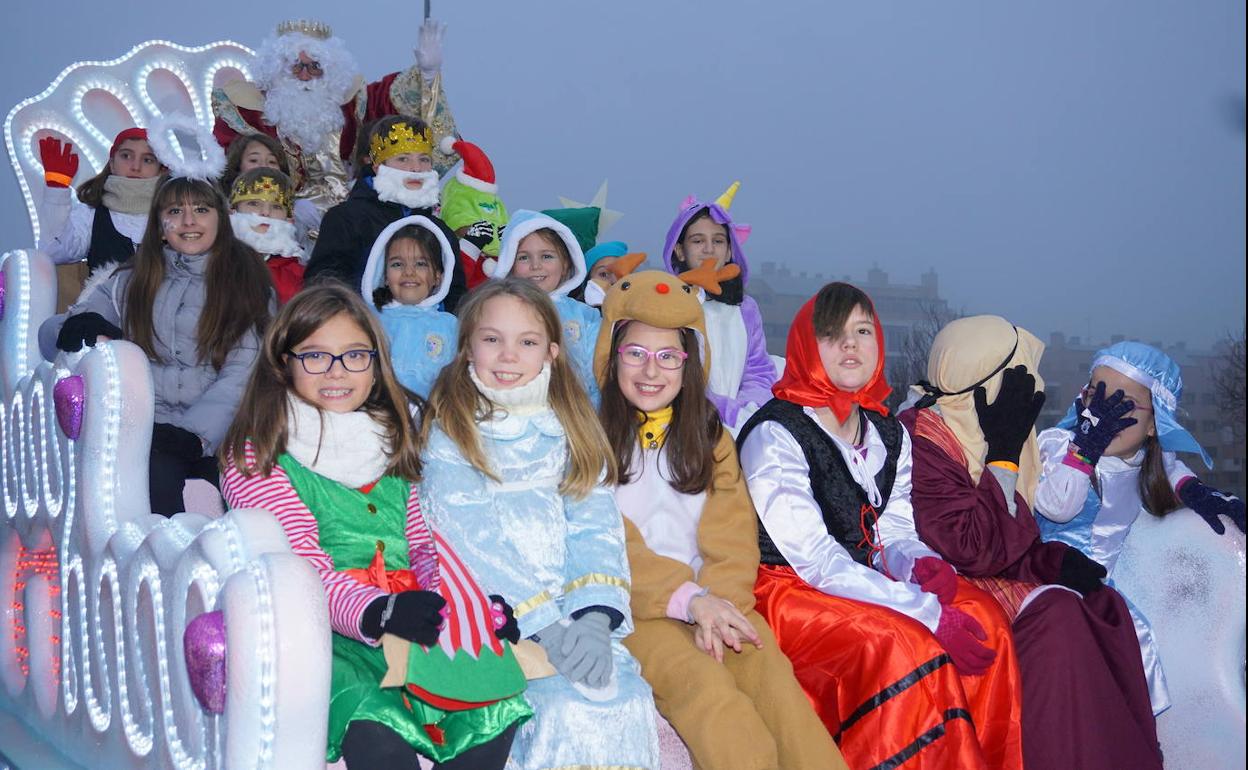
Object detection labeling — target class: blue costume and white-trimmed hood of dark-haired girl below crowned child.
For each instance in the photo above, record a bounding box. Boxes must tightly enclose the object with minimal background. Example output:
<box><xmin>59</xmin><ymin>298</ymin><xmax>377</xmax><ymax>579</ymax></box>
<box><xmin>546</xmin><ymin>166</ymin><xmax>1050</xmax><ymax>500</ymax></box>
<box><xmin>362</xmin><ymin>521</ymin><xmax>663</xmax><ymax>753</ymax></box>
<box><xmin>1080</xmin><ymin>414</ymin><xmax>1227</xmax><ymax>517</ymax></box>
<box><xmin>359</xmin><ymin>215</ymin><xmax>459</xmax><ymax>398</ymax></box>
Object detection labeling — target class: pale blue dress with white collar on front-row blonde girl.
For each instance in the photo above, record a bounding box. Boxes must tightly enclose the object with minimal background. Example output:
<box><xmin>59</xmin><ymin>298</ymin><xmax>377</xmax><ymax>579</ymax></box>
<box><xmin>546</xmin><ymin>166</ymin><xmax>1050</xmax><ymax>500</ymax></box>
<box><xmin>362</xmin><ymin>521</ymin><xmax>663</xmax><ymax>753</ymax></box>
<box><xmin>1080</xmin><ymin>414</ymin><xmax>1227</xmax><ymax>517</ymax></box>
<box><xmin>421</xmin><ymin>366</ymin><xmax>659</xmax><ymax>770</ymax></box>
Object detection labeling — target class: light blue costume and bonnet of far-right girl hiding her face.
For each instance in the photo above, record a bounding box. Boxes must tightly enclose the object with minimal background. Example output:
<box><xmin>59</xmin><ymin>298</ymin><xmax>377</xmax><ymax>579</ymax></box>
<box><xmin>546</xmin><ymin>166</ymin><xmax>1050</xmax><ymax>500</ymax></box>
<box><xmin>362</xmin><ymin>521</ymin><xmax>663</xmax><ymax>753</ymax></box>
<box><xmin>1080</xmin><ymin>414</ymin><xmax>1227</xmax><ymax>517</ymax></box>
<box><xmin>1036</xmin><ymin>342</ymin><xmax>1213</xmax><ymax>714</ymax></box>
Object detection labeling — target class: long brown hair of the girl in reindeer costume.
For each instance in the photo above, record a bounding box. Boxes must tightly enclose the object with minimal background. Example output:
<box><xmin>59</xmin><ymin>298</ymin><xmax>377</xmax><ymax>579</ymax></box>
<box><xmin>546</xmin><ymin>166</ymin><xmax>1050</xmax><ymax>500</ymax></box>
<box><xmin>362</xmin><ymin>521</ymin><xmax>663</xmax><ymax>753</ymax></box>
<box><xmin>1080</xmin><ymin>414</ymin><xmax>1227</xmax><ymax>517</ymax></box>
<box><xmin>598</xmin><ymin>322</ymin><xmax>724</xmax><ymax>494</ymax></box>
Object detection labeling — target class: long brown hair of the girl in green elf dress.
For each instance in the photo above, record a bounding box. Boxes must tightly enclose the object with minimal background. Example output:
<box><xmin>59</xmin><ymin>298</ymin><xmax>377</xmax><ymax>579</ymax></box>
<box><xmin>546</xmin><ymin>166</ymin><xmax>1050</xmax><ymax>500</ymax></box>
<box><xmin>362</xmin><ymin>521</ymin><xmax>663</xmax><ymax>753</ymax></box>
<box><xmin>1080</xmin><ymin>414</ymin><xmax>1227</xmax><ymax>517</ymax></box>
<box><xmin>221</xmin><ymin>281</ymin><xmax>424</xmax><ymax>482</ymax></box>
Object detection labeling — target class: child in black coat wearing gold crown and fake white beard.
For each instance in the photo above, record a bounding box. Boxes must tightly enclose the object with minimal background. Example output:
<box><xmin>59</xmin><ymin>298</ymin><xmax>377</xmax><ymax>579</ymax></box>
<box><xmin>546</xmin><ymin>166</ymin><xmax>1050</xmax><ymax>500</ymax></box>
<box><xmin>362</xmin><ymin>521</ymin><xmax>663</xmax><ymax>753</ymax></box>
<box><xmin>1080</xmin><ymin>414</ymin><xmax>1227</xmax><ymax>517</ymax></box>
<box><xmin>306</xmin><ymin>115</ymin><xmax>466</xmax><ymax>312</ymax></box>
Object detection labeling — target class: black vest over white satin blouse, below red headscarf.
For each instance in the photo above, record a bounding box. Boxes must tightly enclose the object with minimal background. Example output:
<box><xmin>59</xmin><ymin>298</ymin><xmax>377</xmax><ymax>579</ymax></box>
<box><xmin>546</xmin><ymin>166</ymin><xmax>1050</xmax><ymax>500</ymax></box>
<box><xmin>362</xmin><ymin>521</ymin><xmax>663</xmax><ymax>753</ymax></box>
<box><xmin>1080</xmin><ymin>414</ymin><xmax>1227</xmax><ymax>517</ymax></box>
<box><xmin>736</xmin><ymin>398</ymin><xmax>904</xmax><ymax>567</ymax></box>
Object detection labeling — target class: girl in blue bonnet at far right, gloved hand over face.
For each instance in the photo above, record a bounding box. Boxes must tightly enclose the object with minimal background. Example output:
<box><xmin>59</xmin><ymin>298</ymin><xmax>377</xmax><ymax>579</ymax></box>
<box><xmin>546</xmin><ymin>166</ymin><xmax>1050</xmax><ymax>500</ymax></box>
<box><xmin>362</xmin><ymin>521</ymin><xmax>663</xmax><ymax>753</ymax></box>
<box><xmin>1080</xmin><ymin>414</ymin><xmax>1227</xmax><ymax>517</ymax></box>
<box><xmin>1036</xmin><ymin>342</ymin><xmax>1244</xmax><ymax>714</ymax></box>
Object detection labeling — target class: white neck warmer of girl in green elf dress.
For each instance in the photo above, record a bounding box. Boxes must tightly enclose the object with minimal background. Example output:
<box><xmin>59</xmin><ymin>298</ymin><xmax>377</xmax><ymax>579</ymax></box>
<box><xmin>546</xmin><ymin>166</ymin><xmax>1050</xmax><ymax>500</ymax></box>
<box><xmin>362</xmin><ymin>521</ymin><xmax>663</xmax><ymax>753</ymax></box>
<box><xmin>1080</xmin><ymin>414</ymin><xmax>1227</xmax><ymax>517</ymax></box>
<box><xmin>286</xmin><ymin>393</ymin><xmax>389</xmax><ymax>489</ymax></box>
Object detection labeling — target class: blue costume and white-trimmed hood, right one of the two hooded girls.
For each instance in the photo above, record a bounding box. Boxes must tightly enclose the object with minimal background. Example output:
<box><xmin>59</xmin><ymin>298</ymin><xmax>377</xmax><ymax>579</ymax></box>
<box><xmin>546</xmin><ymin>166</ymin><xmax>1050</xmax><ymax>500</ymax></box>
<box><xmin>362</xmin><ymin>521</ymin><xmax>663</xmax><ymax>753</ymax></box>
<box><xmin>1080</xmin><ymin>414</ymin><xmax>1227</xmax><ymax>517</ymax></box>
<box><xmin>490</xmin><ymin>210</ymin><xmax>603</xmax><ymax>408</ymax></box>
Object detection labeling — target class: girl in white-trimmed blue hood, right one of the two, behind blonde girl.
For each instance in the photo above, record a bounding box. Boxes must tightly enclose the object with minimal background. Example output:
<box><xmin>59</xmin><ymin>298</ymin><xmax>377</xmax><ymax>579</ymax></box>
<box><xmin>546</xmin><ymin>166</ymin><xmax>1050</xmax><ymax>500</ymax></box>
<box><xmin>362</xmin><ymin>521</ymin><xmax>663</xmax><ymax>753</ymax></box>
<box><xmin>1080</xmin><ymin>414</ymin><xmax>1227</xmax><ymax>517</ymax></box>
<box><xmin>490</xmin><ymin>210</ymin><xmax>602</xmax><ymax>408</ymax></box>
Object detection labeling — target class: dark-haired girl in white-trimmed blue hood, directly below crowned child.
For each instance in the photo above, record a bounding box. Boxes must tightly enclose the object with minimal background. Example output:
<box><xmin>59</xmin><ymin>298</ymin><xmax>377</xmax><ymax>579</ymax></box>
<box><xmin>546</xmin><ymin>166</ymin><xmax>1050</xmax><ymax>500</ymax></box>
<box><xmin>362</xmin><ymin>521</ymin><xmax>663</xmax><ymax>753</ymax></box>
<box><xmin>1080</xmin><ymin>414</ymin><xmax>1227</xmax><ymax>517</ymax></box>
<box><xmin>359</xmin><ymin>215</ymin><xmax>458</xmax><ymax>397</ymax></box>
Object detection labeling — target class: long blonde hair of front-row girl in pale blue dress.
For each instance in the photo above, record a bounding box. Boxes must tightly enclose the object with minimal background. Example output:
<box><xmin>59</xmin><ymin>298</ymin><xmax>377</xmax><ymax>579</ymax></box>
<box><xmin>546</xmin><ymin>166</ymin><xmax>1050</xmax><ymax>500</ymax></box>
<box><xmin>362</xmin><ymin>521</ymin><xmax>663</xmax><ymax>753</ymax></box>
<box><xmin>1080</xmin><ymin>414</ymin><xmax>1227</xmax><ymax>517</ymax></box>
<box><xmin>424</xmin><ymin>278</ymin><xmax>615</xmax><ymax>498</ymax></box>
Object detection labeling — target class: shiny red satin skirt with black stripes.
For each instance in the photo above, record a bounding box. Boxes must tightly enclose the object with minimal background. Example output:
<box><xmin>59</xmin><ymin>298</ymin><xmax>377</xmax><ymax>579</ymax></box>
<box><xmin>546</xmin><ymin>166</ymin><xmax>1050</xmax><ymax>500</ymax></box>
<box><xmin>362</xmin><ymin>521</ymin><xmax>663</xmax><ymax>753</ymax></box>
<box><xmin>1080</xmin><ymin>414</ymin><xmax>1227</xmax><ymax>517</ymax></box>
<box><xmin>754</xmin><ymin>565</ymin><xmax>1022</xmax><ymax>770</ymax></box>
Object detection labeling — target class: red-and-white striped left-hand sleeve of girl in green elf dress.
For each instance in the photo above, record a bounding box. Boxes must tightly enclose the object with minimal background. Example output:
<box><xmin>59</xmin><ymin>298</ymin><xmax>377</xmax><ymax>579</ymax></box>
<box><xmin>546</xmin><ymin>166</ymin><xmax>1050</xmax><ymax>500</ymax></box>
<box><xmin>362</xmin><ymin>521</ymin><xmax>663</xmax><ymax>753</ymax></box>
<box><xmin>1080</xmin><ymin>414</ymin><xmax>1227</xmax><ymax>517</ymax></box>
<box><xmin>221</xmin><ymin>444</ymin><xmax>386</xmax><ymax>646</ymax></box>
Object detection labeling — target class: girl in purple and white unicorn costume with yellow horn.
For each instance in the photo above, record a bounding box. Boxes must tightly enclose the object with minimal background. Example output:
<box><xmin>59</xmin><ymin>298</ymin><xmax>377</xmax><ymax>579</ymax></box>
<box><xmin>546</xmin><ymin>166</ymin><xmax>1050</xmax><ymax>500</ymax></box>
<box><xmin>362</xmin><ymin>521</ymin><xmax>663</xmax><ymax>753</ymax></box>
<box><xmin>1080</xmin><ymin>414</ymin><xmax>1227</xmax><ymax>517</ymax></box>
<box><xmin>663</xmin><ymin>182</ymin><xmax>776</xmax><ymax>433</ymax></box>
